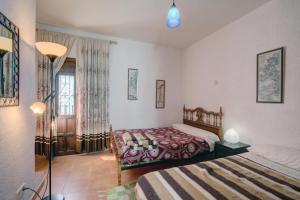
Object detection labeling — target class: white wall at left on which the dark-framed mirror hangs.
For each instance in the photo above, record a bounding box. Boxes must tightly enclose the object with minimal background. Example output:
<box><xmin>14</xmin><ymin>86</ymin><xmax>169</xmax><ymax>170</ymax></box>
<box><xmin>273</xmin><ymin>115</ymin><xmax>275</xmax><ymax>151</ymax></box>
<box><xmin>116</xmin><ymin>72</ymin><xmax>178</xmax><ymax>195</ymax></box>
<box><xmin>0</xmin><ymin>0</ymin><xmax>41</xmax><ymax>200</ymax></box>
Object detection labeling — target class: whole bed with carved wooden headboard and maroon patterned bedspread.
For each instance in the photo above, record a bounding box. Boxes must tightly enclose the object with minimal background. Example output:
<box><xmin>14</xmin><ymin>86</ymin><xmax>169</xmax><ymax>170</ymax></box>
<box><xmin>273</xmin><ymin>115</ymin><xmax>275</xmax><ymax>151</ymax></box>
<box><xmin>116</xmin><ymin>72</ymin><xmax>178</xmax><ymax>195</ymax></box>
<box><xmin>110</xmin><ymin>106</ymin><xmax>223</xmax><ymax>185</ymax></box>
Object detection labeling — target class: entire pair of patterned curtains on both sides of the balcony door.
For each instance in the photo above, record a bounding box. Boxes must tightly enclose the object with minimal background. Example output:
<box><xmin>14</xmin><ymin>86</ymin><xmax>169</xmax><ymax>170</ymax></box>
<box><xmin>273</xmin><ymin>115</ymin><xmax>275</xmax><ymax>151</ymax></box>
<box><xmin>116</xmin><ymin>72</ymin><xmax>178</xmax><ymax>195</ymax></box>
<box><xmin>35</xmin><ymin>30</ymin><xmax>110</xmax><ymax>155</ymax></box>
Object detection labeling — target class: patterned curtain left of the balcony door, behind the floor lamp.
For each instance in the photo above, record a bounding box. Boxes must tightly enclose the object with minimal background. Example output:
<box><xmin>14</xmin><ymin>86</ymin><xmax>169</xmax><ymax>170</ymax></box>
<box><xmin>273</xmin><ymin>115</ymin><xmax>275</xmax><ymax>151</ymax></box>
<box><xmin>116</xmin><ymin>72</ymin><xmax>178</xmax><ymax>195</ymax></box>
<box><xmin>35</xmin><ymin>29</ymin><xmax>76</xmax><ymax>155</ymax></box>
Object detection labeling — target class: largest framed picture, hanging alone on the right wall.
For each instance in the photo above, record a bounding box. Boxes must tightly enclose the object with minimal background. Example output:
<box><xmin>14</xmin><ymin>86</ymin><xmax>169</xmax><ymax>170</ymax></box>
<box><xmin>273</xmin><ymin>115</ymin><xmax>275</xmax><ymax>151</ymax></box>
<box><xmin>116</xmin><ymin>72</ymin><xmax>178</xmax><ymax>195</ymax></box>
<box><xmin>256</xmin><ymin>47</ymin><xmax>284</xmax><ymax>103</ymax></box>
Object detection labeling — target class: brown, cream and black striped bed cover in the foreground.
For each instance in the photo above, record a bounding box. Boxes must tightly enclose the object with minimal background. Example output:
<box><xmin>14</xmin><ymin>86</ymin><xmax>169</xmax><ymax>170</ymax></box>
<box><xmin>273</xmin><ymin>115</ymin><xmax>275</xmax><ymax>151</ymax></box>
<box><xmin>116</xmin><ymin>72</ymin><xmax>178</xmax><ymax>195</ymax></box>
<box><xmin>136</xmin><ymin>156</ymin><xmax>300</xmax><ymax>200</ymax></box>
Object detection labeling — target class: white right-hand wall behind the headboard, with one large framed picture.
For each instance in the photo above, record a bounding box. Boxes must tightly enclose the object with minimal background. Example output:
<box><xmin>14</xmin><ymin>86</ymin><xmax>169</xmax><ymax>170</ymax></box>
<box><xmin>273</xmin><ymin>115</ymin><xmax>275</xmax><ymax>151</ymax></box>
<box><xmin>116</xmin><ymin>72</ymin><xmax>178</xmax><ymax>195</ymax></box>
<box><xmin>183</xmin><ymin>0</ymin><xmax>300</xmax><ymax>147</ymax></box>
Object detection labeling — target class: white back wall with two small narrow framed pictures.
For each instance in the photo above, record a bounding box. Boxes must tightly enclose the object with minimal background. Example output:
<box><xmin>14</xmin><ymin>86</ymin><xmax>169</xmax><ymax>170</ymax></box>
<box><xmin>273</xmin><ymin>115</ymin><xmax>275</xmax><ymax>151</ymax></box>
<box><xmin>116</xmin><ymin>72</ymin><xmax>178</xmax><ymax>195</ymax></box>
<box><xmin>38</xmin><ymin>24</ymin><xmax>183</xmax><ymax>129</ymax></box>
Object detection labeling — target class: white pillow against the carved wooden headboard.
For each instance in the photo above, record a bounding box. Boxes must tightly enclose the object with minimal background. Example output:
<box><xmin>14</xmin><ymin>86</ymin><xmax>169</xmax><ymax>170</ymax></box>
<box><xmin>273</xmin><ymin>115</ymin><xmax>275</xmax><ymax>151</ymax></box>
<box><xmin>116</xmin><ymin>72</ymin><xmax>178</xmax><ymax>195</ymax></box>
<box><xmin>172</xmin><ymin>124</ymin><xmax>220</xmax><ymax>151</ymax></box>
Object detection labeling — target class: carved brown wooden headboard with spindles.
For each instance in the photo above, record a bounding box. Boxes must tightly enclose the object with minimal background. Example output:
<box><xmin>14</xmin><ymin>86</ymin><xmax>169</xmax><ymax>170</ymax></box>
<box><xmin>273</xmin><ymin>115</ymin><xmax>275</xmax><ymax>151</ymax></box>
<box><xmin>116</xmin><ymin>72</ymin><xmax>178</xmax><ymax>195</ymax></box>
<box><xmin>183</xmin><ymin>105</ymin><xmax>223</xmax><ymax>138</ymax></box>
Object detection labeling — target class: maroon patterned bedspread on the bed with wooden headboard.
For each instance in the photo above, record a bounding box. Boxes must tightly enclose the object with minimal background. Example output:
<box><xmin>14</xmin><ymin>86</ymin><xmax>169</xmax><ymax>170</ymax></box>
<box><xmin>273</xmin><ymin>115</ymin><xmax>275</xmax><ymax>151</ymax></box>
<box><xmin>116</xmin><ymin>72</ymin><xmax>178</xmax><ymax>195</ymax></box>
<box><xmin>114</xmin><ymin>127</ymin><xmax>210</xmax><ymax>166</ymax></box>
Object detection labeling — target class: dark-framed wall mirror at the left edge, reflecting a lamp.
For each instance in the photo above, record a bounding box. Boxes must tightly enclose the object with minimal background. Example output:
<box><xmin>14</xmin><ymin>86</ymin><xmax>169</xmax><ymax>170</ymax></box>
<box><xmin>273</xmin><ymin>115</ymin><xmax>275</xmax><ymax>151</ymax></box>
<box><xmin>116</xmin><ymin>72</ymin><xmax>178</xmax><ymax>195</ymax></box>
<box><xmin>0</xmin><ymin>12</ymin><xmax>19</xmax><ymax>106</ymax></box>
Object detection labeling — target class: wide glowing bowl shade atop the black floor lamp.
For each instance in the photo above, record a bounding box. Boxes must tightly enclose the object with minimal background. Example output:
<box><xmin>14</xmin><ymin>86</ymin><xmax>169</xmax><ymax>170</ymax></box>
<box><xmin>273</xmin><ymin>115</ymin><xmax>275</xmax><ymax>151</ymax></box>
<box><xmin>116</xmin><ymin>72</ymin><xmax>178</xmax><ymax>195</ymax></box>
<box><xmin>35</xmin><ymin>42</ymin><xmax>67</xmax><ymax>57</ymax></box>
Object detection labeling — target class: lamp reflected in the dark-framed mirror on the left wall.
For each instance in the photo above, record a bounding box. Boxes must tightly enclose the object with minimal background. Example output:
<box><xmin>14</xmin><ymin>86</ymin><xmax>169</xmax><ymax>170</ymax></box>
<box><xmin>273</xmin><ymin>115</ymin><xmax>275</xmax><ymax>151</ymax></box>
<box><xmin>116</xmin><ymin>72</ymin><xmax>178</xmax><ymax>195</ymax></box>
<box><xmin>0</xmin><ymin>36</ymin><xmax>12</xmax><ymax>95</ymax></box>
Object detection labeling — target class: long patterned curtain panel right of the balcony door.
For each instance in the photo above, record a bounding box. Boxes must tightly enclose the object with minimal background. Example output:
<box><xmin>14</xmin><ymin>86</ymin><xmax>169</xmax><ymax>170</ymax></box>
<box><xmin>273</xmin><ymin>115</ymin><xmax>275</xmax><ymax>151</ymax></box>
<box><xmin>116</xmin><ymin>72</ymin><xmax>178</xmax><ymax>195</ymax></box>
<box><xmin>76</xmin><ymin>39</ymin><xmax>109</xmax><ymax>153</ymax></box>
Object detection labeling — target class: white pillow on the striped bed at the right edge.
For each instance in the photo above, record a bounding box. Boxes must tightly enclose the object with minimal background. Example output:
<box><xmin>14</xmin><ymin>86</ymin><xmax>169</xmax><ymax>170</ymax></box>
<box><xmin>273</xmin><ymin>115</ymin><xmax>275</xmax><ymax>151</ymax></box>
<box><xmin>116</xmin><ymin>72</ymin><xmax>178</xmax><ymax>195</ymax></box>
<box><xmin>250</xmin><ymin>144</ymin><xmax>300</xmax><ymax>171</ymax></box>
